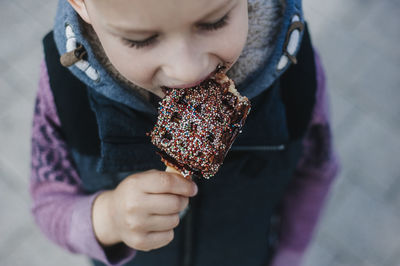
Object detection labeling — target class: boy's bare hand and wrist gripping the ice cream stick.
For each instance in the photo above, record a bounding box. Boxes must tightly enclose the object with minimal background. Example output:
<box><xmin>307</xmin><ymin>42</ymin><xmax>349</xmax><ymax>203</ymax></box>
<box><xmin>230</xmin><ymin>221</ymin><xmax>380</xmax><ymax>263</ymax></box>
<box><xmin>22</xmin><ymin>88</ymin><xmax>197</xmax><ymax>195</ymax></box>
<box><xmin>92</xmin><ymin>170</ymin><xmax>197</xmax><ymax>251</ymax></box>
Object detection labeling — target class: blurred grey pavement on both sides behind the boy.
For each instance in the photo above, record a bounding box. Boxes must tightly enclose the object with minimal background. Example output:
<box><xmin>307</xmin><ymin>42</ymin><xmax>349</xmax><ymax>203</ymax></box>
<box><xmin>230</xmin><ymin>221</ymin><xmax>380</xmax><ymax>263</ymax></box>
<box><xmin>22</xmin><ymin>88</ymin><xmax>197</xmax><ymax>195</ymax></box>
<box><xmin>0</xmin><ymin>0</ymin><xmax>400</xmax><ymax>266</ymax></box>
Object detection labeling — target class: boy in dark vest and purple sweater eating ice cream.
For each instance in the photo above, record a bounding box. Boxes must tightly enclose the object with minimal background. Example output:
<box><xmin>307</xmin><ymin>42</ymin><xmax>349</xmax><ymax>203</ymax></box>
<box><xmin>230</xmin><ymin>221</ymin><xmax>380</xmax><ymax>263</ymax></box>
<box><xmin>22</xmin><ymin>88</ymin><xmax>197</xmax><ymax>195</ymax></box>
<box><xmin>31</xmin><ymin>0</ymin><xmax>337</xmax><ymax>265</ymax></box>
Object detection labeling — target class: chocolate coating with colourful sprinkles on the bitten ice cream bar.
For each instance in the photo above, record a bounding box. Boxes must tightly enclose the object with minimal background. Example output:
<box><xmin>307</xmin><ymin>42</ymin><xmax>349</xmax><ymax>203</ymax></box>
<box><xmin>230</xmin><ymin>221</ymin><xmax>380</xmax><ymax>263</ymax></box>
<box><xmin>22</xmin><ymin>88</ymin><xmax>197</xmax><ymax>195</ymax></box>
<box><xmin>150</xmin><ymin>73</ymin><xmax>250</xmax><ymax>178</ymax></box>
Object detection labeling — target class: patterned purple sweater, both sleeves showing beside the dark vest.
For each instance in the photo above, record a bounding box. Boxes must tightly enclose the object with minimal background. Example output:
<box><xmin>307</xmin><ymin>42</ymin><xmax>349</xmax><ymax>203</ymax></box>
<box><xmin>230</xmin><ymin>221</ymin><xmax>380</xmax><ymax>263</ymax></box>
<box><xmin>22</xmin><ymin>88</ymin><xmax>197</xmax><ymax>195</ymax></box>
<box><xmin>30</xmin><ymin>52</ymin><xmax>338</xmax><ymax>266</ymax></box>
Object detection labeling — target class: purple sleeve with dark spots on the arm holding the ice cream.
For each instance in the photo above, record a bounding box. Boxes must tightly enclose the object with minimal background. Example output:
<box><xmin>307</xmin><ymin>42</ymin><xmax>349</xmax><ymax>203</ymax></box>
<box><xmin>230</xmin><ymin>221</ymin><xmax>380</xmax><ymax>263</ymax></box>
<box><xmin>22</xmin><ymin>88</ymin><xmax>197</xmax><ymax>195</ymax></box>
<box><xmin>30</xmin><ymin>62</ymin><xmax>135</xmax><ymax>265</ymax></box>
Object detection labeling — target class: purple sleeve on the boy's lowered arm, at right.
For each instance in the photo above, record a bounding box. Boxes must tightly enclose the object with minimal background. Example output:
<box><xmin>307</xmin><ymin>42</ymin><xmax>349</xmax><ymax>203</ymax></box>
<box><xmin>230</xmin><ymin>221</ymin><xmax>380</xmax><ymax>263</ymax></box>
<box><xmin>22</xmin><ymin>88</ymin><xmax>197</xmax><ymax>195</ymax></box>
<box><xmin>272</xmin><ymin>50</ymin><xmax>339</xmax><ymax>266</ymax></box>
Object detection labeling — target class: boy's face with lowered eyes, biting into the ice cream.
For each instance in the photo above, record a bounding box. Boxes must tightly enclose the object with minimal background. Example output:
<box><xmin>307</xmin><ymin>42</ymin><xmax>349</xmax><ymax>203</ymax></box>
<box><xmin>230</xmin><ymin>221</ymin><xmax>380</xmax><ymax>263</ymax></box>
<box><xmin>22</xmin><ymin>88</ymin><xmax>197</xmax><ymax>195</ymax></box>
<box><xmin>69</xmin><ymin>0</ymin><xmax>248</xmax><ymax>96</ymax></box>
